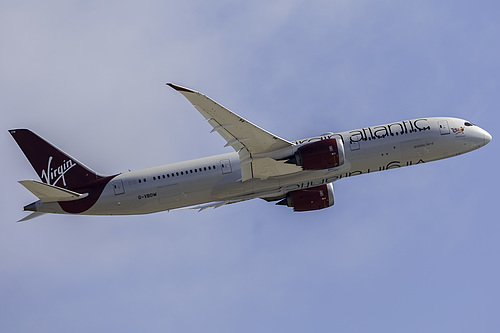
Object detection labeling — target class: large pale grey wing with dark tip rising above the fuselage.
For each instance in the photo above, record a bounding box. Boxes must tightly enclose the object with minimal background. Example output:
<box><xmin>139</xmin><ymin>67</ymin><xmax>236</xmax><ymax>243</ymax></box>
<box><xmin>167</xmin><ymin>83</ymin><xmax>301</xmax><ymax>181</ymax></box>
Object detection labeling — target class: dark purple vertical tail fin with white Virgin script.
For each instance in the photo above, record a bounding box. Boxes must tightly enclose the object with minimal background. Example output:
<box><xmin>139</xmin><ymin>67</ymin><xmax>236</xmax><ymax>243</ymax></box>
<box><xmin>9</xmin><ymin>129</ymin><xmax>103</xmax><ymax>189</ymax></box>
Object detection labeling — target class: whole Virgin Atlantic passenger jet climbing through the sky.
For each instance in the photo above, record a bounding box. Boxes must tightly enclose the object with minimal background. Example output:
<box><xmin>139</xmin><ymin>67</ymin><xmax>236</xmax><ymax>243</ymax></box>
<box><xmin>9</xmin><ymin>83</ymin><xmax>491</xmax><ymax>222</ymax></box>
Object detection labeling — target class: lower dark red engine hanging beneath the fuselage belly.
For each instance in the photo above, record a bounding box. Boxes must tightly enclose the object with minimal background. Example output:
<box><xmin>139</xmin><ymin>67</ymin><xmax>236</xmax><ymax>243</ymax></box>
<box><xmin>278</xmin><ymin>183</ymin><xmax>334</xmax><ymax>212</ymax></box>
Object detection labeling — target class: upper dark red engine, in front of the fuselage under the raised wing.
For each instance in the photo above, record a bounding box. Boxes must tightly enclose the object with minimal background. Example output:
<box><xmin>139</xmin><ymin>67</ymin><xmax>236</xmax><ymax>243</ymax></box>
<box><xmin>287</xmin><ymin>139</ymin><xmax>344</xmax><ymax>170</ymax></box>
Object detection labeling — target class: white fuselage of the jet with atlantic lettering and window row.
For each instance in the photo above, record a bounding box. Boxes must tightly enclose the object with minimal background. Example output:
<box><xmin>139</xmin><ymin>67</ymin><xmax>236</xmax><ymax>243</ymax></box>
<box><xmin>37</xmin><ymin>118</ymin><xmax>491</xmax><ymax>215</ymax></box>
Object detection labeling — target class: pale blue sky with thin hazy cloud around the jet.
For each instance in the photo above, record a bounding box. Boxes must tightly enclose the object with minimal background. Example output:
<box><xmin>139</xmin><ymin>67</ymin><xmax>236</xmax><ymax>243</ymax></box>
<box><xmin>0</xmin><ymin>0</ymin><xmax>500</xmax><ymax>332</ymax></box>
